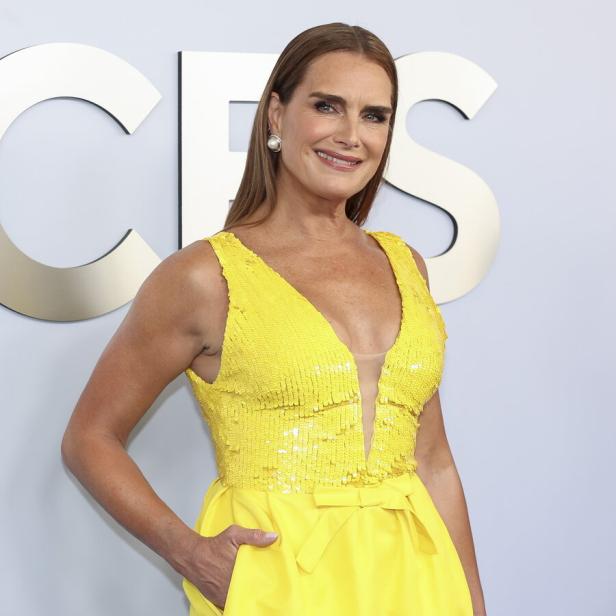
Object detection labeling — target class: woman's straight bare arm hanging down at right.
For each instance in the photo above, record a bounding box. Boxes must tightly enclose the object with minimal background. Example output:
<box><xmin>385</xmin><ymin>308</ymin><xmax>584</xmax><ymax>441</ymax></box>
<box><xmin>409</xmin><ymin>246</ymin><xmax>486</xmax><ymax>616</ymax></box>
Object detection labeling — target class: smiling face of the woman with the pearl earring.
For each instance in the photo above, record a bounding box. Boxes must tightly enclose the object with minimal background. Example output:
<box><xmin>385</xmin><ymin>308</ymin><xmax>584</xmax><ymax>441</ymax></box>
<box><xmin>269</xmin><ymin>52</ymin><xmax>391</xmax><ymax>202</ymax></box>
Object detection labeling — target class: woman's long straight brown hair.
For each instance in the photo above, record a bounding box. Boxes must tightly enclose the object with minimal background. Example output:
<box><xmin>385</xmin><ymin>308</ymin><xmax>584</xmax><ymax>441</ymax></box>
<box><xmin>224</xmin><ymin>22</ymin><xmax>398</xmax><ymax>229</ymax></box>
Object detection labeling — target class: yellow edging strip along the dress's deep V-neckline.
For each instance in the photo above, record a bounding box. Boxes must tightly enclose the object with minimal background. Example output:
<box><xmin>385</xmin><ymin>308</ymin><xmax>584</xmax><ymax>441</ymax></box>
<box><xmin>219</xmin><ymin>229</ymin><xmax>408</xmax><ymax>469</ymax></box>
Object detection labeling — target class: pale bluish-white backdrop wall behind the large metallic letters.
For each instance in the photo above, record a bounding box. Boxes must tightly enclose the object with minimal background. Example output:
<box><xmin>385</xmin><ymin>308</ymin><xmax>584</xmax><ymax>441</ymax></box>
<box><xmin>0</xmin><ymin>0</ymin><xmax>616</xmax><ymax>616</ymax></box>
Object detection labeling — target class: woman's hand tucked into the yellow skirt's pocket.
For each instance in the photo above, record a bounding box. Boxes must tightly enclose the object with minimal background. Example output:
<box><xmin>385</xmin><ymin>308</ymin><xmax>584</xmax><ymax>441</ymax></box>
<box><xmin>183</xmin><ymin>524</ymin><xmax>277</xmax><ymax>609</ymax></box>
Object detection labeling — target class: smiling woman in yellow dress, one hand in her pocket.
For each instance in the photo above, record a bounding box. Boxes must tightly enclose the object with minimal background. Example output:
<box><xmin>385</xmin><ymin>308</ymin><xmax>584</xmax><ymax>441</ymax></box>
<box><xmin>62</xmin><ymin>23</ymin><xmax>485</xmax><ymax>616</ymax></box>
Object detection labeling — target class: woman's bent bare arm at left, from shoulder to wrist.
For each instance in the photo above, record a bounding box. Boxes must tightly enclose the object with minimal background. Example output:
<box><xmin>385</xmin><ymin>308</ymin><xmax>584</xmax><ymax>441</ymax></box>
<box><xmin>61</xmin><ymin>242</ymin><xmax>218</xmax><ymax>574</ymax></box>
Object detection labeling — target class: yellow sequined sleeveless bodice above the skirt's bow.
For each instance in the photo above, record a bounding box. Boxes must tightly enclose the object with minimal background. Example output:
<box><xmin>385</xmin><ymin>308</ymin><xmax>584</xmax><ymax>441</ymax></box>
<box><xmin>185</xmin><ymin>231</ymin><xmax>447</xmax><ymax>493</ymax></box>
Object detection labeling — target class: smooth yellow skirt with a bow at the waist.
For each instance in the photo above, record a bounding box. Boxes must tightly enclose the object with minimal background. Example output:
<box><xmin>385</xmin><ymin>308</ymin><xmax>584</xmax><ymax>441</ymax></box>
<box><xmin>182</xmin><ymin>473</ymin><xmax>473</xmax><ymax>616</ymax></box>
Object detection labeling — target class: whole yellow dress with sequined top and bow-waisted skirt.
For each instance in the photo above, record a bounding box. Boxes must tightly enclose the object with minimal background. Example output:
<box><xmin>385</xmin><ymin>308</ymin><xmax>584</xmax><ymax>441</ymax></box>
<box><xmin>182</xmin><ymin>231</ymin><xmax>473</xmax><ymax>616</ymax></box>
